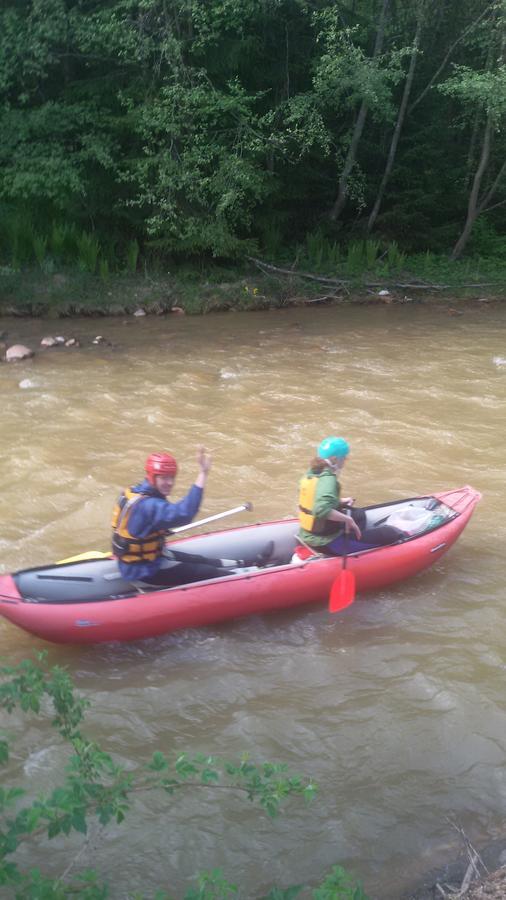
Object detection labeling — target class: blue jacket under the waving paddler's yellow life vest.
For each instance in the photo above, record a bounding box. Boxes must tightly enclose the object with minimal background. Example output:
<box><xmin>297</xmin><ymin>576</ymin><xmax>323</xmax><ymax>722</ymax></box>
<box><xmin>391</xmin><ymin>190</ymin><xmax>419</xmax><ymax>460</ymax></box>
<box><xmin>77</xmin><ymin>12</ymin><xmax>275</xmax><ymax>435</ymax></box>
<box><xmin>118</xmin><ymin>478</ymin><xmax>203</xmax><ymax>581</ymax></box>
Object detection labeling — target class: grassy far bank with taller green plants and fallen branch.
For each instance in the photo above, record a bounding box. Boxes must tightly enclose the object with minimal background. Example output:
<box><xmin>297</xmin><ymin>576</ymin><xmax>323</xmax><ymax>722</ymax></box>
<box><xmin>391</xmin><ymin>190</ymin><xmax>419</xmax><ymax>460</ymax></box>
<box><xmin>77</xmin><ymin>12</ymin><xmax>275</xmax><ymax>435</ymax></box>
<box><xmin>0</xmin><ymin>241</ymin><xmax>506</xmax><ymax>318</ymax></box>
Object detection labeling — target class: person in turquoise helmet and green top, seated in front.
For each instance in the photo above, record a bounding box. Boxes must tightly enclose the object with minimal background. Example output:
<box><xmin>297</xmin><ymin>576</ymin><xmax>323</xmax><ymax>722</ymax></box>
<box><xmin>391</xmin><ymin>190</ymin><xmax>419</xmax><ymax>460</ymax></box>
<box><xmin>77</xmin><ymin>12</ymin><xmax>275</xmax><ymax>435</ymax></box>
<box><xmin>298</xmin><ymin>437</ymin><xmax>400</xmax><ymax>556</ymax></box>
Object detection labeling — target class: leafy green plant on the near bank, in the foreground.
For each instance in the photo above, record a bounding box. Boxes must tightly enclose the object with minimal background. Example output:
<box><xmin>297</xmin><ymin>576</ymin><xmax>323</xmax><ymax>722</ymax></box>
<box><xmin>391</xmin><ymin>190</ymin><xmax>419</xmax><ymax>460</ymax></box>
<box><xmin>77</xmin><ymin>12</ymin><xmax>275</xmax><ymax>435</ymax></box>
<box><xmin>0</xmin><ymin>654</ymin><xmax>365</xmax><ymax>900</ymax></box>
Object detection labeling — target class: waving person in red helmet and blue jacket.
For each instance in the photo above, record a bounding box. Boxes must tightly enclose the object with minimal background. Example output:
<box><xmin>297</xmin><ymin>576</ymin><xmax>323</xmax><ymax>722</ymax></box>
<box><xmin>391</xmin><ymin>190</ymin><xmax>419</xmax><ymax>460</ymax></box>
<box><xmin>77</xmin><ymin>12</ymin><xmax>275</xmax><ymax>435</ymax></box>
<box><xmin>112</xmin><ymin>447</ymin><xmax>240</xmax><ymax>587</ymax></box>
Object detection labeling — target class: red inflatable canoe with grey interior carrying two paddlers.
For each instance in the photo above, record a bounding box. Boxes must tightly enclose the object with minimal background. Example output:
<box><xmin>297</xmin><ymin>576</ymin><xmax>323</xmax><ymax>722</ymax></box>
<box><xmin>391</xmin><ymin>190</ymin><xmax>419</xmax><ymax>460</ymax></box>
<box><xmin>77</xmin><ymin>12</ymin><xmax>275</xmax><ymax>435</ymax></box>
<box><xmin>0</xmin><ymin>486</ymin><xmax>481</xmax><ymax>644</ymax></box>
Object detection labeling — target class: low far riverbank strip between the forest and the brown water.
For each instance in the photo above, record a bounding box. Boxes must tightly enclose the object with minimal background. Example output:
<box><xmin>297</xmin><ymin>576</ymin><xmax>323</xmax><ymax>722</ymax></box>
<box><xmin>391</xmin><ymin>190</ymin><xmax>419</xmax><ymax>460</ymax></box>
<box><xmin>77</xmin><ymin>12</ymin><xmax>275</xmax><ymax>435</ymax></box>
<box><xmin>0</xmin><ymin>262</ymin><xmax>506</xmax><ymax>319</ymax></box>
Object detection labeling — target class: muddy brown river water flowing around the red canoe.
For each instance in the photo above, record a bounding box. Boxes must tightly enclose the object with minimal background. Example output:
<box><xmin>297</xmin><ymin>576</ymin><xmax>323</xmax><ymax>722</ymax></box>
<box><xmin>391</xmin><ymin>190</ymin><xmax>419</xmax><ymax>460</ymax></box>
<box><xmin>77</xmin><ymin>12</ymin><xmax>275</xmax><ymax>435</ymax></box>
<box><xmin>0</xmin><ymin>301</ymin><xmax>506</xmax><ymax>900</ymax></box>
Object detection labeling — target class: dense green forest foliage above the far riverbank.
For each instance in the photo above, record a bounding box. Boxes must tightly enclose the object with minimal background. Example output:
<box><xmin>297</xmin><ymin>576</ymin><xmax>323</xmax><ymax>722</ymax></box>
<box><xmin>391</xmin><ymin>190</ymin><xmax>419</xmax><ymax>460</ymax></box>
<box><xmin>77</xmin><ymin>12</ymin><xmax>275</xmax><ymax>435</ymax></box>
<box><xmin>0</xmin><ymin>0</ymin><xmax>506</xmax><ymax>280</ymax></box>
